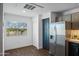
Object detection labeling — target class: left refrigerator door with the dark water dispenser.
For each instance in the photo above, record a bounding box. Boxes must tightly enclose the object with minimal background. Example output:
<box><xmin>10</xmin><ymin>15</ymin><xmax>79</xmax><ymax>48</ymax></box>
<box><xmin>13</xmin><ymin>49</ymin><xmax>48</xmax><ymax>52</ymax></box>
<box><xmin>49</xmin><ymin>23</ymin><xmax>56</xmax><ymax>55</ymax></box>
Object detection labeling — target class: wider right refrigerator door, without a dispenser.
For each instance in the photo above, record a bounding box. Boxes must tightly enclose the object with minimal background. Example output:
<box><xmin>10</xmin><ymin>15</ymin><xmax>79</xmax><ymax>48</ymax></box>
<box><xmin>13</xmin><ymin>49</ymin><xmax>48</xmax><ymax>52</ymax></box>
<box><xmin>56</xmin><ymin>22</ymin><xmax>65</xmax><ymax>56</ymax></box>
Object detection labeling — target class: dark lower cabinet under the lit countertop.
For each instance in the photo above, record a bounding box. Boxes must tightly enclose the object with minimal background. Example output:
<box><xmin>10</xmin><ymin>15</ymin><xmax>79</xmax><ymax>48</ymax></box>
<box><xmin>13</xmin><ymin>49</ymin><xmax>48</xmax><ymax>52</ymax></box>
<box><xmin>68</xmin><ymin>42</ymin><xmax>79</xmax><ymax>56</ymax></box>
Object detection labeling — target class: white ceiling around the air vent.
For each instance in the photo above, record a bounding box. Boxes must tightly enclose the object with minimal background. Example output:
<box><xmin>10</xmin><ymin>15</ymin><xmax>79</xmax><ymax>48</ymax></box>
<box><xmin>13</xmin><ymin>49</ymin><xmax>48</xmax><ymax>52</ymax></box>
<box><xmin>3</xmin><ymin>3</ymin><xmax>79</xmax><ymax>17</ymax></box>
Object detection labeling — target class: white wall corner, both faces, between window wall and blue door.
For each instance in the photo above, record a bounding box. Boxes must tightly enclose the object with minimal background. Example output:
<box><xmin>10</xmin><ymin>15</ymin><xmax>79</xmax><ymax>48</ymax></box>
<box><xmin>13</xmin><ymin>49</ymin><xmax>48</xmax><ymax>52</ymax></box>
<box><xmin>33</xmin><ymin>15</ymin><xmax>43</xmax><ymax>49</ymax></box>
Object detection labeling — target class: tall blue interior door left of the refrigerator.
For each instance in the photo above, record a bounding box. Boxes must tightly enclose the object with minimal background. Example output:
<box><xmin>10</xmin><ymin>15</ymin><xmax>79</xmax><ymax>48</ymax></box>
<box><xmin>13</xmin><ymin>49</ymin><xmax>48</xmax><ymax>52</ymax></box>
<box><xmin>43</xmin><ymin>18</ymin><xmax>49</xmax><ymax>49</ymax></box>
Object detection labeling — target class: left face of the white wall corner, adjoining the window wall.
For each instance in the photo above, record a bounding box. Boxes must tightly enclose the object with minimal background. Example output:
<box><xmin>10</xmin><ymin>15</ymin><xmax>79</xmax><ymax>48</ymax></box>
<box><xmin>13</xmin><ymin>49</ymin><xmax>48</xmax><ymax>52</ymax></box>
<box><xmin>32</xmin><ymin>15</ymin><xmax>39</xmax><ymax>48</ymax></box>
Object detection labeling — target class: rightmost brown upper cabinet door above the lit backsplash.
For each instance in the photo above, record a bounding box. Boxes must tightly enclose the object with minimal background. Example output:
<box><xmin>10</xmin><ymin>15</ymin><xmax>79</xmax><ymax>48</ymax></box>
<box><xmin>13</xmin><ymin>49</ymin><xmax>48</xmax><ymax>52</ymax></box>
<box><xmin>72</xmin><ymin>13</ymin><xmax>79</xmax><ymax>30</ymax></box>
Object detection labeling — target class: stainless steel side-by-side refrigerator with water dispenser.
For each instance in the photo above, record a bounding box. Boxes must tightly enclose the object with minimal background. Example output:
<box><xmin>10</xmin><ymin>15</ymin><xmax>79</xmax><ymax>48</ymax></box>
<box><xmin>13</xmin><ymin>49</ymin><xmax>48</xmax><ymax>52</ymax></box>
<box><xmin>49</xmin><ymin>22</ymin><xmax>69</xmax><ymax>56</ymax></box>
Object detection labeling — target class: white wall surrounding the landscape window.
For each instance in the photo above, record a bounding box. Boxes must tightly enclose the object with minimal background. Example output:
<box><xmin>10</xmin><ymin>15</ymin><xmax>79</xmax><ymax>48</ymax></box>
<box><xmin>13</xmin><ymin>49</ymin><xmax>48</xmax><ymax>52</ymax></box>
<box><xmin>4</xmin><ymin>13</ymin><xmax>33</xmax><ymax>50</ymax></box>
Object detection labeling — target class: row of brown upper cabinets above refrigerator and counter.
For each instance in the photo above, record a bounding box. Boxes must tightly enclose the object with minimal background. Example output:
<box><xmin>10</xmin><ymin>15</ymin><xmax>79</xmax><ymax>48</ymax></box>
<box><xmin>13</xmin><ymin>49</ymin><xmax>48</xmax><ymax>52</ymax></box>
<box><xmin>57</xmin><ymin>13</ymin><xmax>79</xmax><ymax>30</ymax></box>
